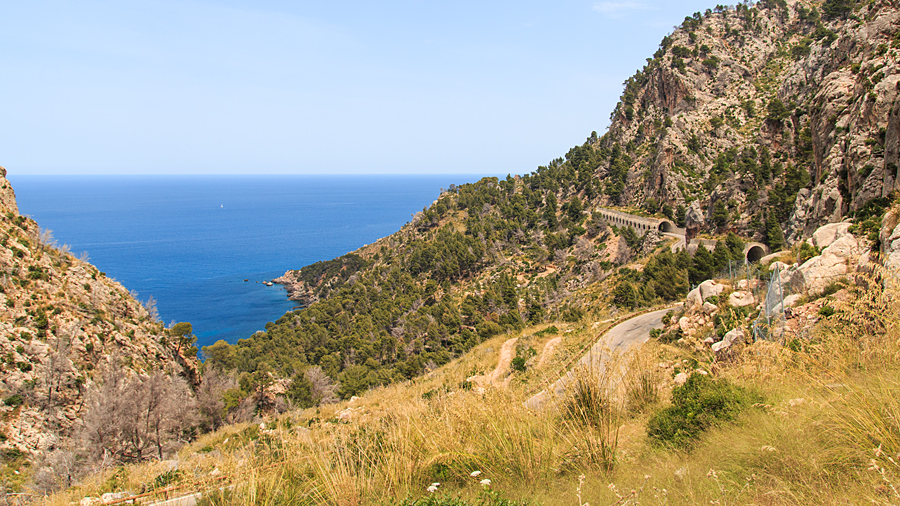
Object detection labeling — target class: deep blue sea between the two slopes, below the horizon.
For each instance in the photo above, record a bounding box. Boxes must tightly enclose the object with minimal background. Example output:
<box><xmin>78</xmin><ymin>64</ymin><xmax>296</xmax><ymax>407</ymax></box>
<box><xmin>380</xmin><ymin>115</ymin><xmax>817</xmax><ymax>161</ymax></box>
<box><xmin>8</xmin><ymin>174</ymin><xmax>486</xmax><ymax>346</ymax></box>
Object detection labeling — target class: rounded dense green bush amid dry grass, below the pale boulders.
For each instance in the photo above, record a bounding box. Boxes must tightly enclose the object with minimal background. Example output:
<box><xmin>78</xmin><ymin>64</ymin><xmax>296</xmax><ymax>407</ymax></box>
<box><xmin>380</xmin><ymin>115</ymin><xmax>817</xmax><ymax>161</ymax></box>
<box><xmin>647</xmin><ymin>373</ymin><xmax>756</xmax><ymax>448</ymax></box>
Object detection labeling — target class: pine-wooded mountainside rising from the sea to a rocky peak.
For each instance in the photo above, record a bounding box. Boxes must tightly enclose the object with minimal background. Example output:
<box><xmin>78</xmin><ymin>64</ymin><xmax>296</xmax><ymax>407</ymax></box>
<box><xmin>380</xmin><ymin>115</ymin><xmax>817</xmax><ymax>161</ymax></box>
<box><xmin>204</xmin><ymin>0</ymin><xmax>900</xmax><ymax>412</ymax></box>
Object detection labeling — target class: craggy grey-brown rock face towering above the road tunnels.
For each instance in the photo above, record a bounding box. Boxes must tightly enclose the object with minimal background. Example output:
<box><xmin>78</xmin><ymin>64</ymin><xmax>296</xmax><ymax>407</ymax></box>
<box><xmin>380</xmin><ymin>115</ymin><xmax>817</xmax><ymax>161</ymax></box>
<box><xmin>589</xmin><ymin>0</ymin><xmax>900</xmax><ymax>247</ymax></box>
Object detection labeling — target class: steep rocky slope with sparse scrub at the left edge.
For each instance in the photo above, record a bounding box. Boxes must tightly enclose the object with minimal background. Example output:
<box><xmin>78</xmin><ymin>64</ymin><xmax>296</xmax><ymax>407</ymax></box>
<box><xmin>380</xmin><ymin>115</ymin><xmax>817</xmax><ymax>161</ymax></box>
<box><xmin>0</xmin><ymin>168</ymin><xmax>199</xmax><ymax>461</ymax></box>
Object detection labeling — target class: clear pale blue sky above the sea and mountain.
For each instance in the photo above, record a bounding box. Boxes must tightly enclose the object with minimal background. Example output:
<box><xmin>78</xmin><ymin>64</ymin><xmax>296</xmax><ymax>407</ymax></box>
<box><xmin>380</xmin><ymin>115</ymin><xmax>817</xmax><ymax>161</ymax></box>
<box><xmin>0</xmin><ymin>0</ymin><xmax>714</xmax><ymax>174</ymax></box>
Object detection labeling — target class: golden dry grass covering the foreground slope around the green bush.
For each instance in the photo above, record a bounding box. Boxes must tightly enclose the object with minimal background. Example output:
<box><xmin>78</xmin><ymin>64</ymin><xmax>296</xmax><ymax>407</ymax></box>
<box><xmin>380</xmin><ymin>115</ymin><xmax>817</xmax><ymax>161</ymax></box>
<box><xmin>40</xmin><ymin>266</ymin><xmax>900</xmax><ymax>506</ymax></box>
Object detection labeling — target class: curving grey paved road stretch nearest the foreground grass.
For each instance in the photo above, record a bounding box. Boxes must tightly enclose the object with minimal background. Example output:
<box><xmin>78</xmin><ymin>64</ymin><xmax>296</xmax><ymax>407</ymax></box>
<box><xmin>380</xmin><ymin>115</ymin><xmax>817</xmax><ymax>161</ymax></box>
<box><xmin>525</xmin><ymin>308</ymin><xmax>672</xmax><ymax>409</ymax></box>
